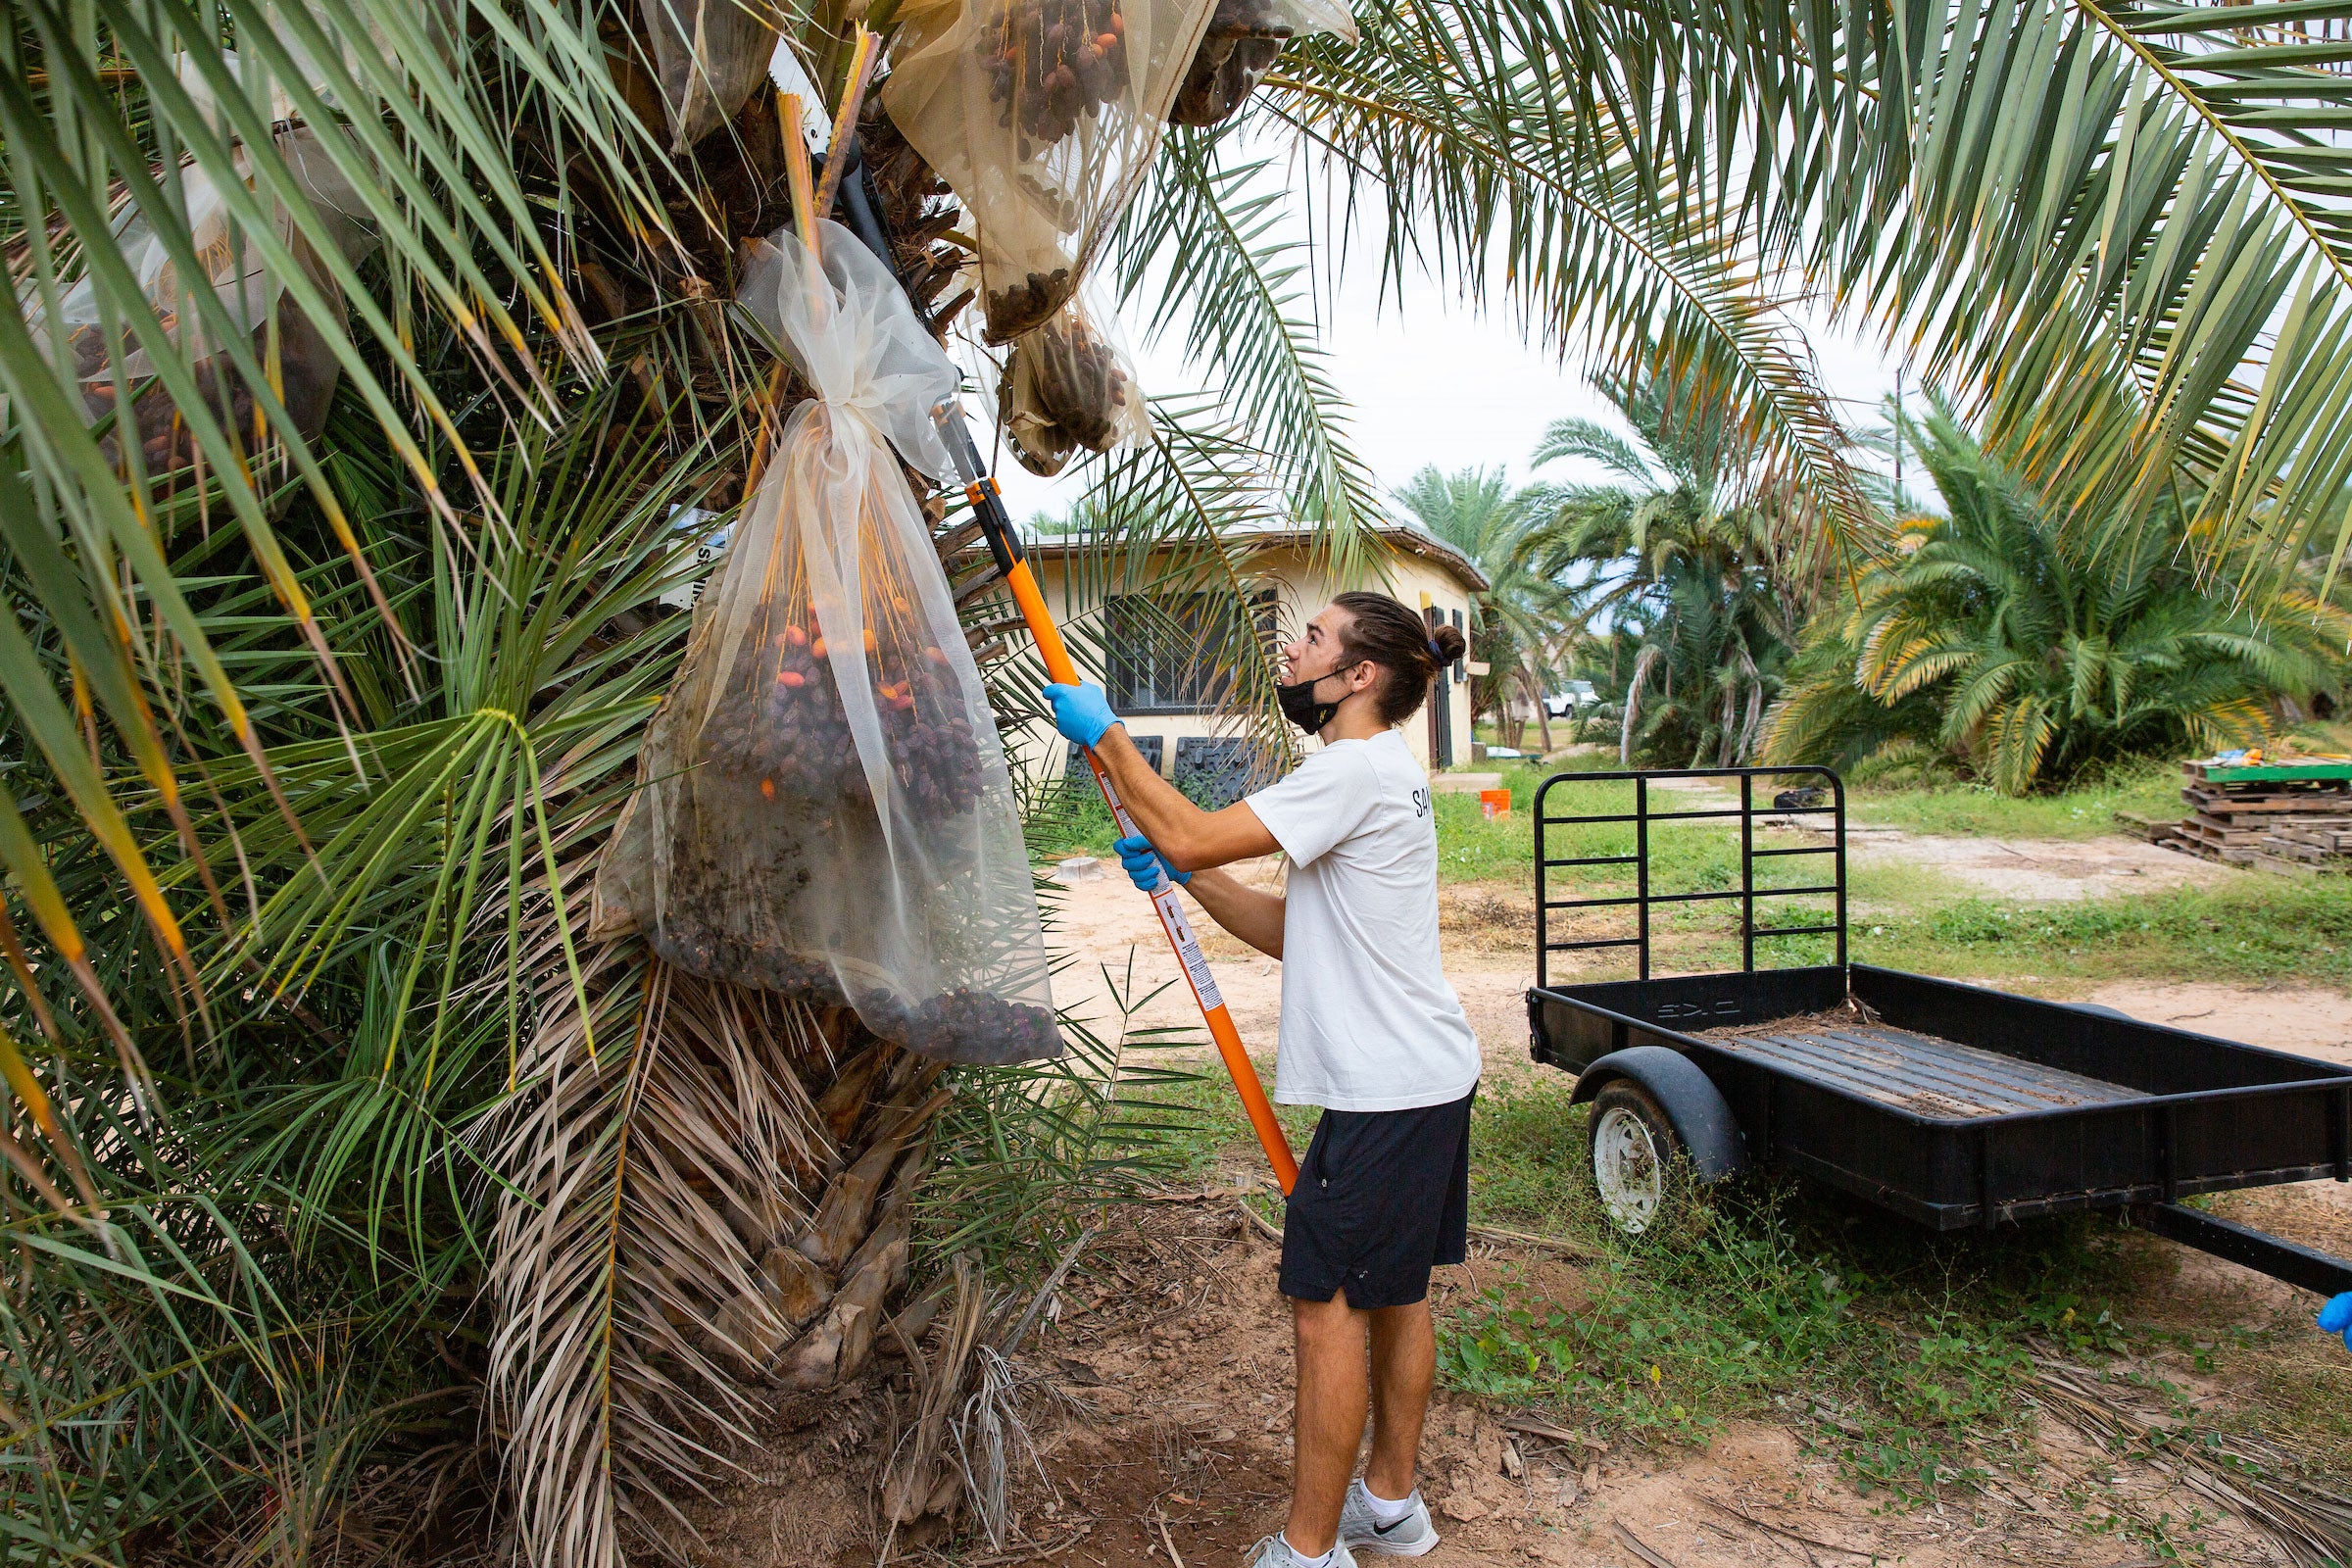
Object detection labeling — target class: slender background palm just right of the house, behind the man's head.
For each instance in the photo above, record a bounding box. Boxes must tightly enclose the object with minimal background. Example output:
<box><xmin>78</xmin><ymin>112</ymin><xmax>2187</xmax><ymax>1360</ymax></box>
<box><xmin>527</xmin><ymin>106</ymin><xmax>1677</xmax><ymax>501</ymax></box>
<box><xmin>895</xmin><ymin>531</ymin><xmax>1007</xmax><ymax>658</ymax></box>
<box><xmin>1395</xmin><ymin>466</ymin><xmax>1574</xmax><ymax>753</ymax></box>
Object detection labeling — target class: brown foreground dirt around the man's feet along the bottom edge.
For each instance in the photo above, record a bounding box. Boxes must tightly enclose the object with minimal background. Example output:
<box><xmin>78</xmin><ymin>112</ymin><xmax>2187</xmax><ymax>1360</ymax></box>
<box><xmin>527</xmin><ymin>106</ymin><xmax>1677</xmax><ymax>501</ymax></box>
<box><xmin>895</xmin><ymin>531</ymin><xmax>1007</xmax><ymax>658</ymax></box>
<box><xmin>694</xmin><ymin>1189</ymin><xmax>2342</xmax><ymax>1568</ymax></box>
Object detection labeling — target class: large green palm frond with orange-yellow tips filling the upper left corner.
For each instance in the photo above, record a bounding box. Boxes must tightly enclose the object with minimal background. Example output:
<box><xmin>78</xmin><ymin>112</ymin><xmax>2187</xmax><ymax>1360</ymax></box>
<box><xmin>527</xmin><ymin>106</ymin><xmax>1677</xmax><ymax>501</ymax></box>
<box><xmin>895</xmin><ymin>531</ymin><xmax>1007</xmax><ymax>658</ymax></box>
<box><xmin>0</xmin><ymin>0</ymin><xmax>665</xmax><ymax>1062</ymax></box>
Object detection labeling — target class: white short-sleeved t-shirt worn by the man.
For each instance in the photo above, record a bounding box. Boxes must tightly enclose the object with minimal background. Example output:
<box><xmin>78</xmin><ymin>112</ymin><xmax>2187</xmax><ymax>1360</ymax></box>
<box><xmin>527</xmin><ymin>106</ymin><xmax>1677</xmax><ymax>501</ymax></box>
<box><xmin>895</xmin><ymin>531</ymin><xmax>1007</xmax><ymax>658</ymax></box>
<box><xmin>1249</xmin><ymin>729</ymin><xmax>1480</xmax><ymax>1109</ymax></box>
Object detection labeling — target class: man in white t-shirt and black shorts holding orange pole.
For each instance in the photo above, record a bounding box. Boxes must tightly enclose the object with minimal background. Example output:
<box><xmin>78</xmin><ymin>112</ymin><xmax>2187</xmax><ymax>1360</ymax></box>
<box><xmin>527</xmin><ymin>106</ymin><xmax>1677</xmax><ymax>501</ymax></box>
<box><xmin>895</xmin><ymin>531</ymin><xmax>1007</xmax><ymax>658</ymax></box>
<box><xmin>1047</xmin><ymin>592</ymin><xmax>1480</xmax><ymax>1568</ymax></box>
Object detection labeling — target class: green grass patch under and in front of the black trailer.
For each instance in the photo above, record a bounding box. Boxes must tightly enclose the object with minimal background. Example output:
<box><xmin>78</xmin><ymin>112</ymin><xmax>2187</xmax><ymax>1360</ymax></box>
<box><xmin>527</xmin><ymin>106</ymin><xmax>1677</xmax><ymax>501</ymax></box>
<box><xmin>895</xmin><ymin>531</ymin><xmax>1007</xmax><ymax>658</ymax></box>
<box><xmin>1440</xmin><ymin>1081</ymin><xmax>2150</xmax><ymax>1499</ymax></box>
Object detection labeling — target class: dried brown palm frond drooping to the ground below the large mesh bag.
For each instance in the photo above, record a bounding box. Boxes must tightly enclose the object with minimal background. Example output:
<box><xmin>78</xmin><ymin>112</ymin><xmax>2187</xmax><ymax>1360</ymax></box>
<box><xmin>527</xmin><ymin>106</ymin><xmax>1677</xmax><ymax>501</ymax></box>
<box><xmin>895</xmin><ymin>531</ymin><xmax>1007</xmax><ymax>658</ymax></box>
<box><xmin>489</xmin><ymin>906</ymin><xmax>833</xmax><ymax>1563</ymax></box>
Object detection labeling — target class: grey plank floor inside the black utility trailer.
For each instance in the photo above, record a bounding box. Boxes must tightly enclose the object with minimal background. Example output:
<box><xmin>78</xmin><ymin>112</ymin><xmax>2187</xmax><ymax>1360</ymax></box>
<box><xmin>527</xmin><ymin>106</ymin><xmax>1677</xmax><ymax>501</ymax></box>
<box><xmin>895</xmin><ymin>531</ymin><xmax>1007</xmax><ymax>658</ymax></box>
<box><xmin>1700</xmin><ymin>1015</ymin><xmax>2147</xmax><ymax>1121</ymax></box>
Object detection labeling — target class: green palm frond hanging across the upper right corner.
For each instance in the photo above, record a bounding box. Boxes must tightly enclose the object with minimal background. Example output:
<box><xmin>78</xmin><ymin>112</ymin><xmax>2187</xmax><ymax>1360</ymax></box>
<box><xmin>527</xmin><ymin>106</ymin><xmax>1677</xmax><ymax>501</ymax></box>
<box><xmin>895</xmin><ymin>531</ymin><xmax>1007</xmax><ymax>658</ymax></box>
<box><xmin>1715</xmin><ymin>0</ymin><xmax>2352</xmax><ymax>578</ymax></box>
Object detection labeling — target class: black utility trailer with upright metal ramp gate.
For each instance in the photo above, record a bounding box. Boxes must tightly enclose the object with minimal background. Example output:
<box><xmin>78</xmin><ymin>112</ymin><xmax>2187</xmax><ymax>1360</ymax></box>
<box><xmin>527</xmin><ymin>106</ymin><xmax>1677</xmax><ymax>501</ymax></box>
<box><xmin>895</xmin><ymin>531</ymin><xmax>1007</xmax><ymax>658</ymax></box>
<box><xmin>1527</xmin><ymin>768</ymin><xmax>2352</xmax><ymax>1296</ymax></box>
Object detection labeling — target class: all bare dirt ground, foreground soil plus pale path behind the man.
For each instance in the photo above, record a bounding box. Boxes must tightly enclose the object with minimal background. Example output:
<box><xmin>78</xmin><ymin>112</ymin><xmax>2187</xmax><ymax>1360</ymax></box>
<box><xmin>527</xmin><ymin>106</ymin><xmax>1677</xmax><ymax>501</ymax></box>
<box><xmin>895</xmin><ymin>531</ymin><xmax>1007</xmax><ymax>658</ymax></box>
<box><xmin>692</xmin><ymin>808</ymin><xmax>2352</xmax><ymax>1568</ymax></box>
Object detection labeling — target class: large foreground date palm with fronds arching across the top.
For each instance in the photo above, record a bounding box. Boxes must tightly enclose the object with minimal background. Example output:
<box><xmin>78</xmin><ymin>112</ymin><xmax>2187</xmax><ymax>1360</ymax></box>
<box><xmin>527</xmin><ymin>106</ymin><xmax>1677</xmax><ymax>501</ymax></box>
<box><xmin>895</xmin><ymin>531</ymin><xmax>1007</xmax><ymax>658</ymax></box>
<box><xmin>14</xmin><ymin>0</ymin><xmax>2352</xmax><ymax>1566</ymax></box>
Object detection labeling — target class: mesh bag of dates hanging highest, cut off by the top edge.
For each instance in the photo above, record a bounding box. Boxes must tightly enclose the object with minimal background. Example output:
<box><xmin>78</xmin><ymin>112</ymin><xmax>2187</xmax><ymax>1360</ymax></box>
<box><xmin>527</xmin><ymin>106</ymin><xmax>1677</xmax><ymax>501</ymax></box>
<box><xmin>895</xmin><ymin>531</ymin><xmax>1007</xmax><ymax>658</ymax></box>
<box><xmin>882</xmin><ymin>0</ymin><xmax>1213</xmax><ymax>343</ymax></box>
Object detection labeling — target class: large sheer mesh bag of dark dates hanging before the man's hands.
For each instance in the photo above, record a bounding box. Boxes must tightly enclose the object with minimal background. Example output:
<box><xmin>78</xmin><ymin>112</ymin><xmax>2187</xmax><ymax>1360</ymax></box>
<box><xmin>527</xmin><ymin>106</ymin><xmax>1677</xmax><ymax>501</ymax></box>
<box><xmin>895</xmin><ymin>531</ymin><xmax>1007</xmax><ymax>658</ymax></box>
<box><xmin>598</xmin><ymin>223</ymin><xmax>1060</xmax><ymax>1062</ymax></box>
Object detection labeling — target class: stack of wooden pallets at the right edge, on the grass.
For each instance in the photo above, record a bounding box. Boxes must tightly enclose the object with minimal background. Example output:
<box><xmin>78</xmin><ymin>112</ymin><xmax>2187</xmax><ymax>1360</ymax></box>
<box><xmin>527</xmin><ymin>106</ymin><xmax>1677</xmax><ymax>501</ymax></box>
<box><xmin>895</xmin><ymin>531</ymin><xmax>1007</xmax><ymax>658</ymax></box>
<box><xmin>2147</xmin><ymin>755</ymin><xmax>2352</xmax><ymax>874</ymax></box>
